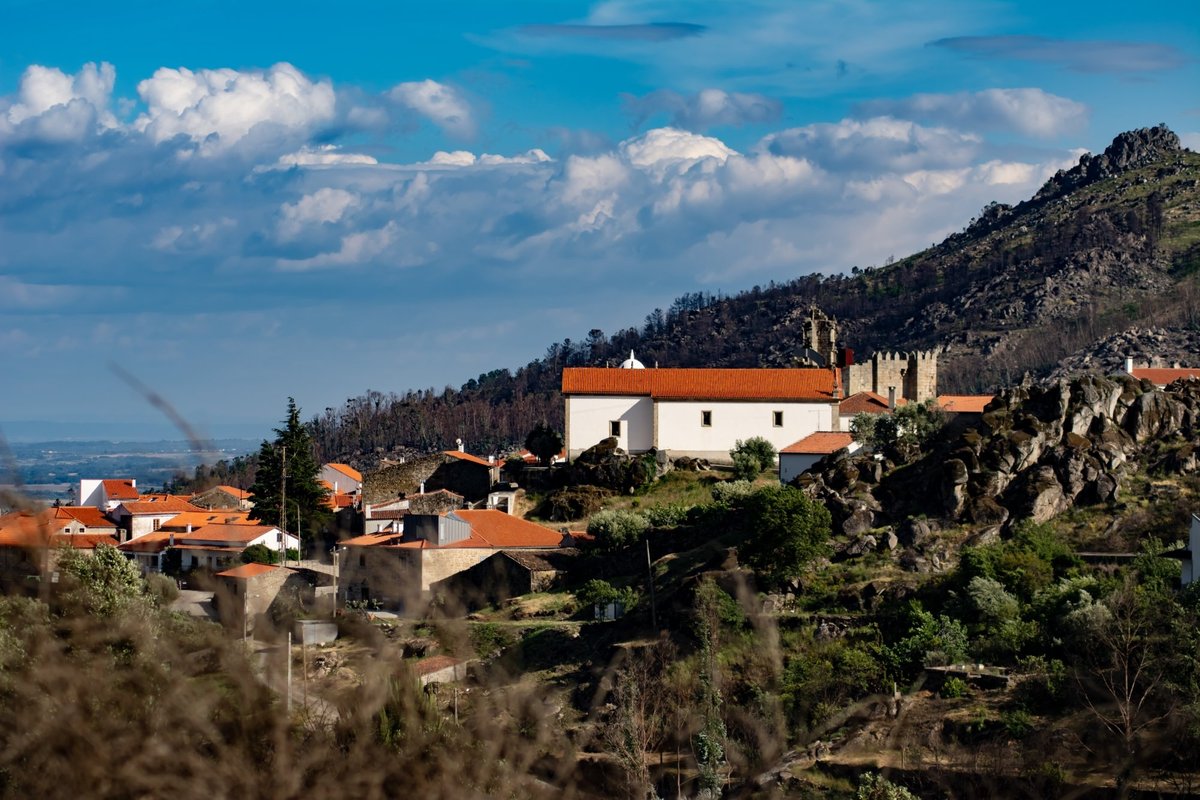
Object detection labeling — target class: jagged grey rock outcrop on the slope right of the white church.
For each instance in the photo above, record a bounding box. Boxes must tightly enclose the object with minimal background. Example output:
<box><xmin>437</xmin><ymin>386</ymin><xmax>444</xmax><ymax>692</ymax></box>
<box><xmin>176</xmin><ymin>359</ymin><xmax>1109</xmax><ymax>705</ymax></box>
<box><xmin>797</xmin><ymin>375</ymin><xmax>1200</xmax><ymax>569</ymax></box>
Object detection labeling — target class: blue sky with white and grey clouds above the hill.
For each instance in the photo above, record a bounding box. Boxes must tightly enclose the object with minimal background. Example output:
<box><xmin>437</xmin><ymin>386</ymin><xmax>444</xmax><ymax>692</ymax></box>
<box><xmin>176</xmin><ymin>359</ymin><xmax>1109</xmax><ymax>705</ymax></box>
<box><xmin>0</xmin><ymin>0</ymin><xmax>1200</xmax><ymax>435</ymax></box>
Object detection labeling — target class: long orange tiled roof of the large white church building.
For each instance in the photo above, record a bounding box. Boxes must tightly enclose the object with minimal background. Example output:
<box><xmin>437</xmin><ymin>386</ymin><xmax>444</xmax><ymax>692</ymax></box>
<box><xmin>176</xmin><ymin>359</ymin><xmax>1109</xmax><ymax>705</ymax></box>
<box><xmin>563</xmin><ymin>367</ymin><xmax>834</xmax><ymax>402</ymax></box>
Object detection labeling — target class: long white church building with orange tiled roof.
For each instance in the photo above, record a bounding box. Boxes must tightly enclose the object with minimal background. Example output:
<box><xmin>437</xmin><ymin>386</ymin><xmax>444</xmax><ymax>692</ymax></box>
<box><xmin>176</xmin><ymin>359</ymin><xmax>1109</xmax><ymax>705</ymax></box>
<box><xmin>563</xmin><ymin>353</ymin><xmax>841</xmax><ymax>462</ymax></box>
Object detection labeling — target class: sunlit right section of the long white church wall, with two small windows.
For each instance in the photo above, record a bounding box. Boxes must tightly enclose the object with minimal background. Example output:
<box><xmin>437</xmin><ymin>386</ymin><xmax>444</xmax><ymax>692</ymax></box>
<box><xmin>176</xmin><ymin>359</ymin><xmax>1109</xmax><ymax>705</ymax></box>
<box><xmin>652</xmin><ymin>398</ymin><xmax>833</xmax><ymax>461</ymax></box>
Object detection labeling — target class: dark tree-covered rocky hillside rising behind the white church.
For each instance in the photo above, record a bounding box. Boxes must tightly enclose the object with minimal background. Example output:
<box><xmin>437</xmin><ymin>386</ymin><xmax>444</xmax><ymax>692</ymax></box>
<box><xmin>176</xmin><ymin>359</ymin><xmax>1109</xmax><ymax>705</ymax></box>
<box><xmin>310</xmin><ymin>127</ymin><xmax>1200</xmax><ymax>465</ymax></box>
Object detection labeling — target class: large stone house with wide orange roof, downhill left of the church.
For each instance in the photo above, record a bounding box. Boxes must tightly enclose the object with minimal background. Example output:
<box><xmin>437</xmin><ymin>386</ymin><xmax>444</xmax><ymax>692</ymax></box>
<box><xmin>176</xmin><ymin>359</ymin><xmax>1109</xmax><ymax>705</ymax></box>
<box><xmin>338</xmin><ymin>509</ymin><xmax>574</xmax><ymax>613</ymax></box>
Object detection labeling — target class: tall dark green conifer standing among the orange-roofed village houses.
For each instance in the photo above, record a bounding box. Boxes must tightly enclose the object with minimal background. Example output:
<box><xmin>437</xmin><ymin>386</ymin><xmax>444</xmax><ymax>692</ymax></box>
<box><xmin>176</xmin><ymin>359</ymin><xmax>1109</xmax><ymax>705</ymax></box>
<box><xmin>250</xmin><ymin>397</ymin><xmax>330</xmax><ymax>554</ymax></box>
